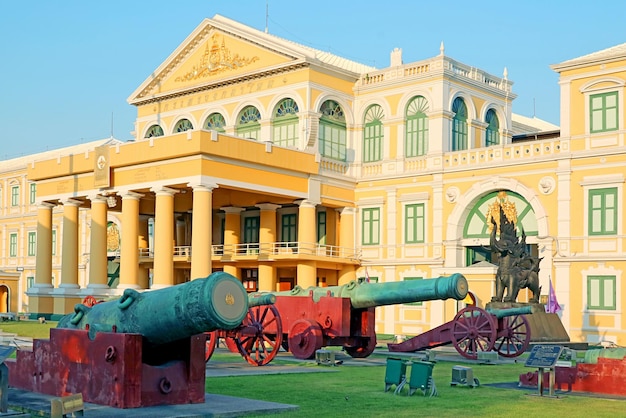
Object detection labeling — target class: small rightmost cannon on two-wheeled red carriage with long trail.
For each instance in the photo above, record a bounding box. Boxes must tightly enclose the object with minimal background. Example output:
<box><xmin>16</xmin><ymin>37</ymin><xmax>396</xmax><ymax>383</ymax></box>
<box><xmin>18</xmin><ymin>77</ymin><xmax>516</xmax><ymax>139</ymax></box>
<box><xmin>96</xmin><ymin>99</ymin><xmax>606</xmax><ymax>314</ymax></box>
<box><xmin>387</xmin><ymin>305</ymin><xmax>532</xmax><ymax>360</ymax></box>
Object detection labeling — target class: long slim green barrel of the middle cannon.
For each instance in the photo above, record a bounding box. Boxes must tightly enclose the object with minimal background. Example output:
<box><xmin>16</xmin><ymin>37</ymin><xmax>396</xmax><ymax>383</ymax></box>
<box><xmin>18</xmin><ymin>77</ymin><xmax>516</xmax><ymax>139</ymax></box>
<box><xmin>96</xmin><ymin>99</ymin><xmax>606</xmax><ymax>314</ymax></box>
<box><xmin>251</xmin><ymin>273</ymin><xmax>468</xmax><ymax>308</ymax></box>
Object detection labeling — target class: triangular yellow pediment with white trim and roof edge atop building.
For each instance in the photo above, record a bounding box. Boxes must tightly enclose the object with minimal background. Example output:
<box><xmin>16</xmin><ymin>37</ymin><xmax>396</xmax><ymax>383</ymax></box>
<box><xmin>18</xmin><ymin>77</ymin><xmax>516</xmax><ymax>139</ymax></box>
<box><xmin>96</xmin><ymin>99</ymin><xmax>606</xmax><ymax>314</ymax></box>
<box><xmin>128</xmin><ymin>15</ymin><xmax>372</xmax><ymax>104</ymax></box>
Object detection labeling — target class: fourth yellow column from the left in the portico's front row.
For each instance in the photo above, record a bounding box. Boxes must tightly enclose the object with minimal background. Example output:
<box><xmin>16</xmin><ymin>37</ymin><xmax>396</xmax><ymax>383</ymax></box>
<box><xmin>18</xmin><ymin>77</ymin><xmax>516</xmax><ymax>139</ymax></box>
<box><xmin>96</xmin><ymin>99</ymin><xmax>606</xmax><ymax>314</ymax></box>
<box><xmin>118</xmin><ymin>192</ymin><xmax>143</xmax><ymax>289</ymax></box>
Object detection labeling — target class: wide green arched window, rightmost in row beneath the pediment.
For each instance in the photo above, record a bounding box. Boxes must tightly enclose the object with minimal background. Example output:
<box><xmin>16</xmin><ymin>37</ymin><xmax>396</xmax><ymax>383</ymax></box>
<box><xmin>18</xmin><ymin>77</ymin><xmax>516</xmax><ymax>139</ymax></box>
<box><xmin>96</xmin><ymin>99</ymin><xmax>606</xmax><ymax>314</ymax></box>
<box><xmin>319</xmin><ymin>100</ymin><xmax>347</xmax><ymax>161</ymax></box>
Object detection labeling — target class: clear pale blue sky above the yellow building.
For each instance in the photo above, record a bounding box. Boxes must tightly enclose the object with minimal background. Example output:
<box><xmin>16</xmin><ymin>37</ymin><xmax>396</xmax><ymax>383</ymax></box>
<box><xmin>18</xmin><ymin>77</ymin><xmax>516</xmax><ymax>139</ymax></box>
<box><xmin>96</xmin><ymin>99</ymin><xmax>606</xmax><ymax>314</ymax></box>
<box><xmin>0</xmin><ymin>0</ymin><xmax>626</xmax><ymax>161</ymax></box>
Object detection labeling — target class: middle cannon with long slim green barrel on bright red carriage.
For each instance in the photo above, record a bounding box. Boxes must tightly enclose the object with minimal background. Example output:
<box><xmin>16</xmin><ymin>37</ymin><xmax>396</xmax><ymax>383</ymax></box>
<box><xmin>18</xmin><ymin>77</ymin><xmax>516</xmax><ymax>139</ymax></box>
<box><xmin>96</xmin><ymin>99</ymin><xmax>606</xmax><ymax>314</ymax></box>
<box><xmin>246</xmin><ymin>274</ymin><xmax>468</xmax><ymax>359</ymax></box>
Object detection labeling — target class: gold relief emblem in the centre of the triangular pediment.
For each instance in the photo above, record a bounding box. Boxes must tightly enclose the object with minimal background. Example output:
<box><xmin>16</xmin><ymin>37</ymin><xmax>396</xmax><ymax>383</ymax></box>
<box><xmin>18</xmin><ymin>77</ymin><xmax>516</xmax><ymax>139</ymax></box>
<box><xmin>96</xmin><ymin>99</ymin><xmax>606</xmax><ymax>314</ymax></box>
<box><xmin>175</xmin><ymin>33</ymin><xmax>259</xmax><ymax>82</ymax></box>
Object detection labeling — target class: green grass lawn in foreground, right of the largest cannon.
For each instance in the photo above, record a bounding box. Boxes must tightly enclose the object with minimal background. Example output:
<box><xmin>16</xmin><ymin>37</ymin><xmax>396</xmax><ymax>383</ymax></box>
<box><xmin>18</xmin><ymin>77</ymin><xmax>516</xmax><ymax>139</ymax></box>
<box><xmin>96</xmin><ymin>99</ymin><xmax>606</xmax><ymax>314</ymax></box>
<box><xmin>206</xmin><ymin>354</ymin><xmax>626</xmax><ymax>418</ymax></box>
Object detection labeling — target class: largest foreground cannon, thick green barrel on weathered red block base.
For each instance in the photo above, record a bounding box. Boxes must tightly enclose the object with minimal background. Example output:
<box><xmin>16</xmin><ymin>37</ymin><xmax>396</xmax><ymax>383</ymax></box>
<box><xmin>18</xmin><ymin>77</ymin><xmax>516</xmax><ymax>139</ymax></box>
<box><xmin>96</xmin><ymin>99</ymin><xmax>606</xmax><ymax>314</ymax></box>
<box><xmin>5</xmin><ymin>272</ymin><xmax>248</xmax><ymax>408</ymax></box>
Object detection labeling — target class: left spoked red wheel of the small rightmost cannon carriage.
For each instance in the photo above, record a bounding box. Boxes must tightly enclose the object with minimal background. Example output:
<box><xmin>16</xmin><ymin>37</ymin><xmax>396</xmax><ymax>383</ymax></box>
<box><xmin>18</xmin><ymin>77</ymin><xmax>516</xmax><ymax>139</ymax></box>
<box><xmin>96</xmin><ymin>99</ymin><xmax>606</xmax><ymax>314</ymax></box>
<box><xmin>451</xmin><ymin>306</ymin><xmax>497</xmax><ymax>360</ymax></box>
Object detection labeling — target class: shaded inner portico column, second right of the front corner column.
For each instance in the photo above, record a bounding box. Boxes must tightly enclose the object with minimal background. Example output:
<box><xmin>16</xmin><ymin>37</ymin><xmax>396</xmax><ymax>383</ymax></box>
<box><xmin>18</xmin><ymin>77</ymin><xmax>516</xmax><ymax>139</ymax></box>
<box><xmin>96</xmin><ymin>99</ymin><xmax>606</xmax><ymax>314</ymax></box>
<box><xmin>256</xmin><ymin>203</ymin><xmax>280</xmax><ymax>291</ymax></box>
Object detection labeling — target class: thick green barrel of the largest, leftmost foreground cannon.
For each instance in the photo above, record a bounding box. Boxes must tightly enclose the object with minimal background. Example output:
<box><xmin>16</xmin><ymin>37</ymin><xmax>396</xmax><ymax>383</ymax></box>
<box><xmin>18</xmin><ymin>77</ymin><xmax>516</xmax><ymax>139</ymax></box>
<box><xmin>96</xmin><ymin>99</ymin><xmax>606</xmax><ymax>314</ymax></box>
<box><xmin>57</xmin><ymin>272</ymin><xmax>248</xmax><ymax>345</ymax></box>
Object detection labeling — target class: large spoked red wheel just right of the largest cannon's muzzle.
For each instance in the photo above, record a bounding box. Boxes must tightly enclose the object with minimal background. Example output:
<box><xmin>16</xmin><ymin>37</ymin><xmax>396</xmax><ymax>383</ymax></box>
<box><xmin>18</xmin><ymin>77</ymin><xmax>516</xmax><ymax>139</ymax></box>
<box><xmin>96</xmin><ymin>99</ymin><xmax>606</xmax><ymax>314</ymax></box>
<box><xmin>235</xmin><ymin>305</ymin><xmax>283</xmax><ymax>366</ymax></box>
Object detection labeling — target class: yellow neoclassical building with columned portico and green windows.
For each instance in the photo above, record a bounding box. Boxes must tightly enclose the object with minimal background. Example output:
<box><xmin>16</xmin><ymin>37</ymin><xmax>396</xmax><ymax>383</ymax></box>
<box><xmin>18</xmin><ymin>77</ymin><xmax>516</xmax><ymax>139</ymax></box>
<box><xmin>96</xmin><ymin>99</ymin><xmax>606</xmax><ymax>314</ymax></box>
<box><xmin>1</xmin><ymin>16</ymin><xmax>626</xmax><ymax>345</ymax></box>
